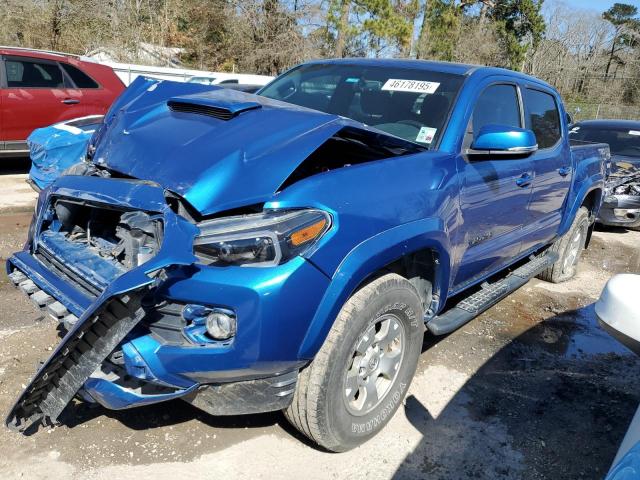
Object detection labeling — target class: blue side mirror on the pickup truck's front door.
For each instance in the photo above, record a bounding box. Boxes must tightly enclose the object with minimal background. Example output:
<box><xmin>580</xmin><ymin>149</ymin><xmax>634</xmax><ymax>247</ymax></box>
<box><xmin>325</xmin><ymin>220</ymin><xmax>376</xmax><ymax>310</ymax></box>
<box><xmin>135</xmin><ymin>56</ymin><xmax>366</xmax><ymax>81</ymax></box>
<box><xmin>467</xmin><ymin>125</ymin><xmax>538</xmax><ymax>156</ymax></box>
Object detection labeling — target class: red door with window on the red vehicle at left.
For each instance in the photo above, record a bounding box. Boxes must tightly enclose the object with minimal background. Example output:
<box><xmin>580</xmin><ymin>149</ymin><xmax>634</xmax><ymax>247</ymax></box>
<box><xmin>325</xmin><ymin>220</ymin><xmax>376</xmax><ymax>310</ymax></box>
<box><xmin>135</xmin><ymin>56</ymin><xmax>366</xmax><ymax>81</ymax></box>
<box><xmin>0</xmin><ymin>56</ymin><xmax>81</xmax><ymax>142</ymax></box>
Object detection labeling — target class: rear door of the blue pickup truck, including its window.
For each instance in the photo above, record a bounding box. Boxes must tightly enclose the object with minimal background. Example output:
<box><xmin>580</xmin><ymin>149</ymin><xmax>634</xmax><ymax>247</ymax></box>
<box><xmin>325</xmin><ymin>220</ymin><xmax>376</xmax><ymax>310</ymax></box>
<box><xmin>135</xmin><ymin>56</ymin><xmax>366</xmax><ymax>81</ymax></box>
<box><xmin>522</xmin><ymin>85</ymin><xmax>573</xmax><ymax>250</ymax></box>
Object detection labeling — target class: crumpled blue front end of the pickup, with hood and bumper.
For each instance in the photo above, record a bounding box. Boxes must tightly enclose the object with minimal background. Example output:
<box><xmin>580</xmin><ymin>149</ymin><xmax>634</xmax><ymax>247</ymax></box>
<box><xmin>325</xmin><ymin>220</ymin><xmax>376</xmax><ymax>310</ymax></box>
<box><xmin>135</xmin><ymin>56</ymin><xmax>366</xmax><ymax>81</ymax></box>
<box><xmin>7</xmin><ymin>79</ymin><xmax>425</xmax><ymax>431</ymax></box>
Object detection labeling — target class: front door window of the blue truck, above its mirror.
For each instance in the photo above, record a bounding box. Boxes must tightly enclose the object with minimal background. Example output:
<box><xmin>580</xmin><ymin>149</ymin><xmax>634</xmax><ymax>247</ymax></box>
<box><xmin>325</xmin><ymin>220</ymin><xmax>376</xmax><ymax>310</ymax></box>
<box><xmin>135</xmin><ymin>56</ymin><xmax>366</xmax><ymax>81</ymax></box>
<box><xmin>472</xmin><ymin>85</ymin><xmax>520</xmax><ymax>134</ymax></box>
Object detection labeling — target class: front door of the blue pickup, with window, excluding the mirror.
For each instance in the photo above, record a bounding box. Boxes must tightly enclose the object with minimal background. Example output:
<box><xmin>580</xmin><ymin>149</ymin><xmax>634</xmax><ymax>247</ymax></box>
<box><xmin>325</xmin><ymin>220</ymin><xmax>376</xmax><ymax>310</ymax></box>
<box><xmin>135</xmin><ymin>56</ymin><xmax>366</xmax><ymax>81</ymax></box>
<box><xmin>454</xmin><ymin>79</ymin><xmax>533</xmax><ymax>290</ymax></box>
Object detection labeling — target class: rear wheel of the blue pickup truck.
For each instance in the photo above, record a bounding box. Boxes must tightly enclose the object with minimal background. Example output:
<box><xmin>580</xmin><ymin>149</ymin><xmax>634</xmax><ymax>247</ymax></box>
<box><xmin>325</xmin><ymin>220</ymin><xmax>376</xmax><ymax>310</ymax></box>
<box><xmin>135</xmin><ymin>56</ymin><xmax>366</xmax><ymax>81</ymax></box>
<box><xmin>538</xmin><ymin>207</ymin><xmax>589</xmax><ymax>283</ymax></box>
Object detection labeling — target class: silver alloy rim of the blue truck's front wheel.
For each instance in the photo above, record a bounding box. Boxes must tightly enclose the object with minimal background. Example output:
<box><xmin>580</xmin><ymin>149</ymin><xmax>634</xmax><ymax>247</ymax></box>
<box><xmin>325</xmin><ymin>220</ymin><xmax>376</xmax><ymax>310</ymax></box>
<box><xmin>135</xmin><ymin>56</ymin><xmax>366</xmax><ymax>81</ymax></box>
<box><xmin>343</xmin><ymin>313</ymin><xmax>406</xmax><ymax>416</ymax></box>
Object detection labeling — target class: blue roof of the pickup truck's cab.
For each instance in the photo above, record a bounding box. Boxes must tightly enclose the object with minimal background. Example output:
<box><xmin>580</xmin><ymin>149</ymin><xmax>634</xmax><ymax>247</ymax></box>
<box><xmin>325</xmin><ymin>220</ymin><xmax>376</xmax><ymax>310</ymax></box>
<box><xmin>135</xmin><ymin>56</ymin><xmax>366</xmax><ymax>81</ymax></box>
<box><xmin>308</xmin><ymin>58</ymin><xmax>555</xmax><ymax>91</ymax></box>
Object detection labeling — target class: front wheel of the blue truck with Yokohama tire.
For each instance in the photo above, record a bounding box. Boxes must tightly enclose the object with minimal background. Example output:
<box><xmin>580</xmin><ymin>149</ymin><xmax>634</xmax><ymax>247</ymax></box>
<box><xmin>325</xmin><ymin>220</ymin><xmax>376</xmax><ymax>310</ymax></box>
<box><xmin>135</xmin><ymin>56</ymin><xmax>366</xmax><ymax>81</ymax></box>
<box><xmin>285</xmin><ymin>273</ymin><xmax>424</xmax><ymax>452</ymax></box>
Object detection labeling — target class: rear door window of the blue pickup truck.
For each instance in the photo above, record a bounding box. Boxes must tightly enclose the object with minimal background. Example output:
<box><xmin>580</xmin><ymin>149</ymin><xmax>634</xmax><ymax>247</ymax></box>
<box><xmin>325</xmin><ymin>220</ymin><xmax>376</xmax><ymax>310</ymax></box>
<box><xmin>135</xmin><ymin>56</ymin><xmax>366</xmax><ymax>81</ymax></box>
<box><xmin>524</xmin><ymin>88</ymin><xmax>560</xmax><ymax>148</ymax></box>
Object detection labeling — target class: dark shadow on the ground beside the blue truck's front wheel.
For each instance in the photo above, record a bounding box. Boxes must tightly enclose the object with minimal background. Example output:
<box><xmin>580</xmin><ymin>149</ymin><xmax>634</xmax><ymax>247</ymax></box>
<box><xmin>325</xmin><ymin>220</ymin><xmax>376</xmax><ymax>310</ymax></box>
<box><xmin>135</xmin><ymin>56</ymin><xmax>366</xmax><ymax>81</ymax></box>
<box><xmin>394</xmin><ymin>305</ymin><xmax>640</xmax><ymax>479</ymax></box>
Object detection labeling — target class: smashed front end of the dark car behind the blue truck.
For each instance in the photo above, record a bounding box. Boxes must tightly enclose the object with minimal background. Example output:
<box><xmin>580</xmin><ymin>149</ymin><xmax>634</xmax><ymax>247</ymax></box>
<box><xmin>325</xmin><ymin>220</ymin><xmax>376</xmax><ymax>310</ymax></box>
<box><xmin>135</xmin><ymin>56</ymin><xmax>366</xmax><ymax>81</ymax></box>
<box><xmin>598</xmin><ymin>161</ymin><xmax>640</xmax><ymax>229</ymax></box>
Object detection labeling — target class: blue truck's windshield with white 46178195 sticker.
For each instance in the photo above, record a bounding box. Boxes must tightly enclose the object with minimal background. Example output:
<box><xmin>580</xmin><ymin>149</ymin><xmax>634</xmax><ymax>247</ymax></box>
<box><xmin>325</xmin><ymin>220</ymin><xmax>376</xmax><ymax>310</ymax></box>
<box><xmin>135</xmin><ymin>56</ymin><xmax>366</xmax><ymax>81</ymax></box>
<box><xmin>260</xmin><ymin>64</ymin><xmax>464</xmax><ymax>146</ymax></box>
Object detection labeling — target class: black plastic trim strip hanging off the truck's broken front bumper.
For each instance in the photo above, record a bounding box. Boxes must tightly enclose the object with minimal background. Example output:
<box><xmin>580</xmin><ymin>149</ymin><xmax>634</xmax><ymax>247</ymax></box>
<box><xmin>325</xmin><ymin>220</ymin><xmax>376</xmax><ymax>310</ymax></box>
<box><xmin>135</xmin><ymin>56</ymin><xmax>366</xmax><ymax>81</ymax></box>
<box><xmin>6</xmin><ymin>291</ymin><xmax>144</xmax><ymax>433</ymax></box>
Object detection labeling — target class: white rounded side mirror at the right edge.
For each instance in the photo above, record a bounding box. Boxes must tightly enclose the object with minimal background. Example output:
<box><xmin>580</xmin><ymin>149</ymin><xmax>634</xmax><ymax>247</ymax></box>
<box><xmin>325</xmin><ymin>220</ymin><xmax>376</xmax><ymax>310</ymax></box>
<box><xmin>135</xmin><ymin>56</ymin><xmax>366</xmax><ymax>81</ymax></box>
<box><xmin>595</xmin><ymin>273</ymin><xmax>640</xmax><ymax>355</ymax></box>
